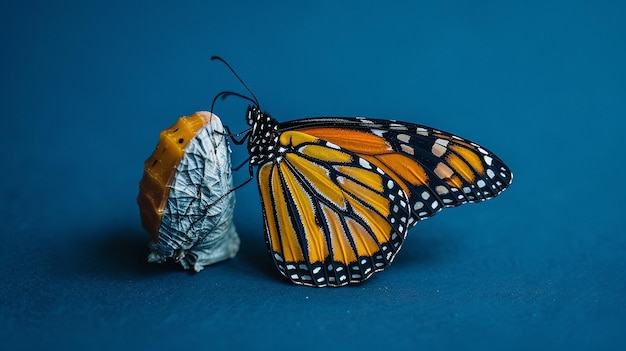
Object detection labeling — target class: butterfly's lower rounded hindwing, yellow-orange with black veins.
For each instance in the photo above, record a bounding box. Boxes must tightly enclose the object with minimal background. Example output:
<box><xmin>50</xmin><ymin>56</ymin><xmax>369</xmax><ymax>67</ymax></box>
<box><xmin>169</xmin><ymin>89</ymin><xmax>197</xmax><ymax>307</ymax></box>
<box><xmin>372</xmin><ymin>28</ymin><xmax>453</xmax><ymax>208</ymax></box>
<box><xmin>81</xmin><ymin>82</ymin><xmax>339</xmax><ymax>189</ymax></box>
<box><xmin>258</xmin><ymin>131</ymin><xmax>411</xmax><ymax>286</ymax></box>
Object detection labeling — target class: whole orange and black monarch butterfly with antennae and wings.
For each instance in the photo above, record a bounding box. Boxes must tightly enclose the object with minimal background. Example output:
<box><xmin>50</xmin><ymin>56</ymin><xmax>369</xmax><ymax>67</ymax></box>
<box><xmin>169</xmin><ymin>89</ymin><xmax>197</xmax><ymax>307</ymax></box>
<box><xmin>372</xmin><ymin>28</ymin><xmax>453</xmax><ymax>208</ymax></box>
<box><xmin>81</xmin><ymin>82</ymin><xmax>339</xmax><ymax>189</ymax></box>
<box><xmin>212</xmin><ymin>56</ymin><xmax>513</xmax><ymax>287</ymax></box>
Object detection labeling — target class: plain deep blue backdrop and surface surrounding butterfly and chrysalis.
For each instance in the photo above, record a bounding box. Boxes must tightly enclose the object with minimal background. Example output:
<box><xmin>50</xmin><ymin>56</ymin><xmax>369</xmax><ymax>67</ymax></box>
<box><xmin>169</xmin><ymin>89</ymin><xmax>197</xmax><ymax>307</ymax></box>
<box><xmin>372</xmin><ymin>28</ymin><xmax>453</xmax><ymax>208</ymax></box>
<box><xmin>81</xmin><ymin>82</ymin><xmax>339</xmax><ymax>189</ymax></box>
<box><xmin>0</xmin><ymin>0</ymin><xmax>626</xmax><ymax>350</ymax></box>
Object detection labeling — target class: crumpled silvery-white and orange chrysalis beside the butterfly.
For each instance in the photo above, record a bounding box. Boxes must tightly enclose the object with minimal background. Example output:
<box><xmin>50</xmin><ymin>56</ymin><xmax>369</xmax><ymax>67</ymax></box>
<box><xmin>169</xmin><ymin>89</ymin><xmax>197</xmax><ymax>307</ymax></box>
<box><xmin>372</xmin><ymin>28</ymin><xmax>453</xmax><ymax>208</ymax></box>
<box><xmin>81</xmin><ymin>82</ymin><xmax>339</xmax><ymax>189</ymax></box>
<box><xmin>137</xmin><ymin>111</ymin><xmax>239</xmax><ymax>272</ymax></box>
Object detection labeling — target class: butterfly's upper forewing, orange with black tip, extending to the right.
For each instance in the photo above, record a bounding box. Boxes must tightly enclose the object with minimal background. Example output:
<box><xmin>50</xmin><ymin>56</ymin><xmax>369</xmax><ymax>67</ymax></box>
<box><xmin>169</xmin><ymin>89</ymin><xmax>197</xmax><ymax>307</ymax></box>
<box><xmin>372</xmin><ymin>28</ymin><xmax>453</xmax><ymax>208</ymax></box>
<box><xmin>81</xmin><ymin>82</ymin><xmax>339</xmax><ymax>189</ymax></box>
<box><xmin>281</xmin><ymin>117</ymin><xmax>513</xmax><ymax>221</ymax></box>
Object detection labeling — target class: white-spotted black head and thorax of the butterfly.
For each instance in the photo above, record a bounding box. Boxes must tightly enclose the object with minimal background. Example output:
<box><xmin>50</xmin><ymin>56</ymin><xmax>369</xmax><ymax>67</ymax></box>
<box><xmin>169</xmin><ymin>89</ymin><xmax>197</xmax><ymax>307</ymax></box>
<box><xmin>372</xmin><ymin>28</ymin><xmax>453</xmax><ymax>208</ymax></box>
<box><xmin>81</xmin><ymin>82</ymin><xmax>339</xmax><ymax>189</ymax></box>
<box><xmin>246</xmin><ymin>106</ymin><xmax>286</xmax><ymax>165</ymax></box>
